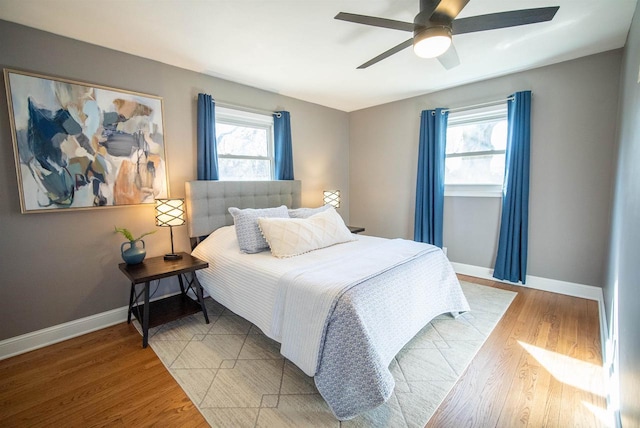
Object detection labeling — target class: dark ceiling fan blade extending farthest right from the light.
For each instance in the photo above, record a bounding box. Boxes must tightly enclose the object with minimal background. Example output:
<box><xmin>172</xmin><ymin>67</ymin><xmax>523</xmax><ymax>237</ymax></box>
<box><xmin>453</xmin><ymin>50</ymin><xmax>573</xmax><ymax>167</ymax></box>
<box><xmin>451</xmin><ymin>6</ymin><xmax>560</xmax><ymax>35</ymax></box>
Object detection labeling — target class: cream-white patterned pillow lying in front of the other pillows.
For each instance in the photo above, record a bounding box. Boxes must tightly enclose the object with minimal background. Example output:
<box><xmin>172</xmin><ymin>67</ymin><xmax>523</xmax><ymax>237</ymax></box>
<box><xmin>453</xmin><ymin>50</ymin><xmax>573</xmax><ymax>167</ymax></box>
<box><xmin>258</xmin><ymin>207</ymin><xmax>357</xmax><ymax>258</ymax></box>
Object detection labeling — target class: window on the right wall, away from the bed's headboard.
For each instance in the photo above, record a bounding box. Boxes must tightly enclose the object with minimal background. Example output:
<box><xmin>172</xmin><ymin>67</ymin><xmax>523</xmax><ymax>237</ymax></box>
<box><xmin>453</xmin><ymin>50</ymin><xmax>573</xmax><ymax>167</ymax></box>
<box><xmin>444</xmin><ymin>103</ymin><xmax>507</xmax><ymax>196</ymax></box>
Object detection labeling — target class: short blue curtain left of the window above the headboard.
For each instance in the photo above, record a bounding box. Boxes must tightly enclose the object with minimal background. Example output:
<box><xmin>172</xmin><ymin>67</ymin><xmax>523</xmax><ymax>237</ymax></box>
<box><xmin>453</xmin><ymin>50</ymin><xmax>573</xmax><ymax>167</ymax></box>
<box><xmin>198</xmin><ymin>94</ymin><xmax>218</xmax><ymax>180</ymax></box>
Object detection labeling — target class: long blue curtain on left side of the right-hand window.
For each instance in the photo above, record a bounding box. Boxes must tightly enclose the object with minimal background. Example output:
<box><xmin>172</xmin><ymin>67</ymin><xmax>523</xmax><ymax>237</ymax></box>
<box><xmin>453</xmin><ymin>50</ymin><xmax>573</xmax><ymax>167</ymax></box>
<box><xmin>413</xmin><ymin>108</ymin><xmax>449</xmax><ymax>248</ymax></box>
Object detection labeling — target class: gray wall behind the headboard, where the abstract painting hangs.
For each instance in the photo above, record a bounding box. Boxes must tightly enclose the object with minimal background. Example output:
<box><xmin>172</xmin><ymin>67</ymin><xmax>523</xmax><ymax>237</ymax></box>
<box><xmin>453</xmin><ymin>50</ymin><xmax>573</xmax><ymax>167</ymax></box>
<box><xmin>0</xmin><ymin>21</ymin><xmax>349</xmax><ymax>340</ymax></box>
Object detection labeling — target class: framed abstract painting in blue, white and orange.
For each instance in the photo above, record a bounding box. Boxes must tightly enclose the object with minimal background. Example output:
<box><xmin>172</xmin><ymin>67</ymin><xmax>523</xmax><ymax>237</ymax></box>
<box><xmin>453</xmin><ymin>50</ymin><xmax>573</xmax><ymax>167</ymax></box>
<box><xmin>4</xmin><ymin>69</ymin><xmax>168</xmax><ymax>213</ymax></box>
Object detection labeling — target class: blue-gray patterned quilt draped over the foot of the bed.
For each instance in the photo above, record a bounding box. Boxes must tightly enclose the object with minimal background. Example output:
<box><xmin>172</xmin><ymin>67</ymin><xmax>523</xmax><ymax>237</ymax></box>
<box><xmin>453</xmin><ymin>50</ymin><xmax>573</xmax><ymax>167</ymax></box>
<box><xmin>314</xmin><ymin>244</ymin><xmax>469</xmax><ymax>420</ymax></box>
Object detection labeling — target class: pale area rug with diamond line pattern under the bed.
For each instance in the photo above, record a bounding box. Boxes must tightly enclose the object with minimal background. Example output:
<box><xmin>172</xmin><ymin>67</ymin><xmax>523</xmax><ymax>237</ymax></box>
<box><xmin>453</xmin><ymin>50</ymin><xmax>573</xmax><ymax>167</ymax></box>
<box><xmin>135</xmin><ymin>282</ymin><xmax>516</xmax><ymax>428</ymax></box>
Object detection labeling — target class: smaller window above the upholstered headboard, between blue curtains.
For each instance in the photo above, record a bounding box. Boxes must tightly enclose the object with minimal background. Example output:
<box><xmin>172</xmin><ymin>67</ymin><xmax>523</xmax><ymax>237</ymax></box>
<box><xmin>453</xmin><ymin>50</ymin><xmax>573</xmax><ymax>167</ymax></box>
<box><xmin>216</xmin><ymin>107</ymin><xmax>273</xmax><ymax>181</ymax></box>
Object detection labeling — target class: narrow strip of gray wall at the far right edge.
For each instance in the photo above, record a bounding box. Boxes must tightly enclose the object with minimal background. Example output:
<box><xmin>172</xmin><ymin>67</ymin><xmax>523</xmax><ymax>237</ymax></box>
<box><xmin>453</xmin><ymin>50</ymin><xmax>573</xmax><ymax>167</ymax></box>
<box><xmin>604</xmin><ymin>2</ymin><xmax>640</xmax><ymax>428</ymax></box>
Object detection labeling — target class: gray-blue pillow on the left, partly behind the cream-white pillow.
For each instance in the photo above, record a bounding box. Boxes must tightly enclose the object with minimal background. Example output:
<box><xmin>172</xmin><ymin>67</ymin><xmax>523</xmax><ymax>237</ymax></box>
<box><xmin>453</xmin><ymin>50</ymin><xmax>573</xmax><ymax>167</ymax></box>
<box><xmin>229</xmin><ymin>205</ymin><xmax>289</xmax><ymax>254</ymax></box>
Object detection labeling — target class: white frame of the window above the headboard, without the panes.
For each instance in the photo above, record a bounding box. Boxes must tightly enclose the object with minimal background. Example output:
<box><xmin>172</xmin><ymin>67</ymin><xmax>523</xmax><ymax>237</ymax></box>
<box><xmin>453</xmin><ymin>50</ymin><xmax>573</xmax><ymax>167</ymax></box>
<box><xmin>216</xmin><ymin>106</ymin><xmax>275</xmax><ymax>181</ymax></box>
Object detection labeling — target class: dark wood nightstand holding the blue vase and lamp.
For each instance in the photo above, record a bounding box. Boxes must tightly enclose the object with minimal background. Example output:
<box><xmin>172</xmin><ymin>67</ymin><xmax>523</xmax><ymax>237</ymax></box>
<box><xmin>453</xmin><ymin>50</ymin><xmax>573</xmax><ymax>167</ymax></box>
<box><xmin>118</xmin><ymin>253</ymin><xmax>209</xmax><ymax>348</ymax></box>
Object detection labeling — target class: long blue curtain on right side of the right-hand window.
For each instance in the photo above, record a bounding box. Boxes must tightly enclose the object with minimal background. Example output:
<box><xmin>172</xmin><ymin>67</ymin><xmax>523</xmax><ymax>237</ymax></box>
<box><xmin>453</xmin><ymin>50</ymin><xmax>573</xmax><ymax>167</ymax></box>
<box><xmin>493</xmin><ymin>91</ymin><xmax>531</xmax><ymax>284</ymax></box>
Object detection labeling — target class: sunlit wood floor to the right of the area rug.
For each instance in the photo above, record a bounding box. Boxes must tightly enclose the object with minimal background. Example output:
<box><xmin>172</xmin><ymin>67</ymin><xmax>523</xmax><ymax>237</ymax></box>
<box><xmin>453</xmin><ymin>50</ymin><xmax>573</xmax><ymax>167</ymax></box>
<box><xmin>427</xmin><ymin>275</ymin><xmax>606</xmax><ymax>428</ymax></box>
